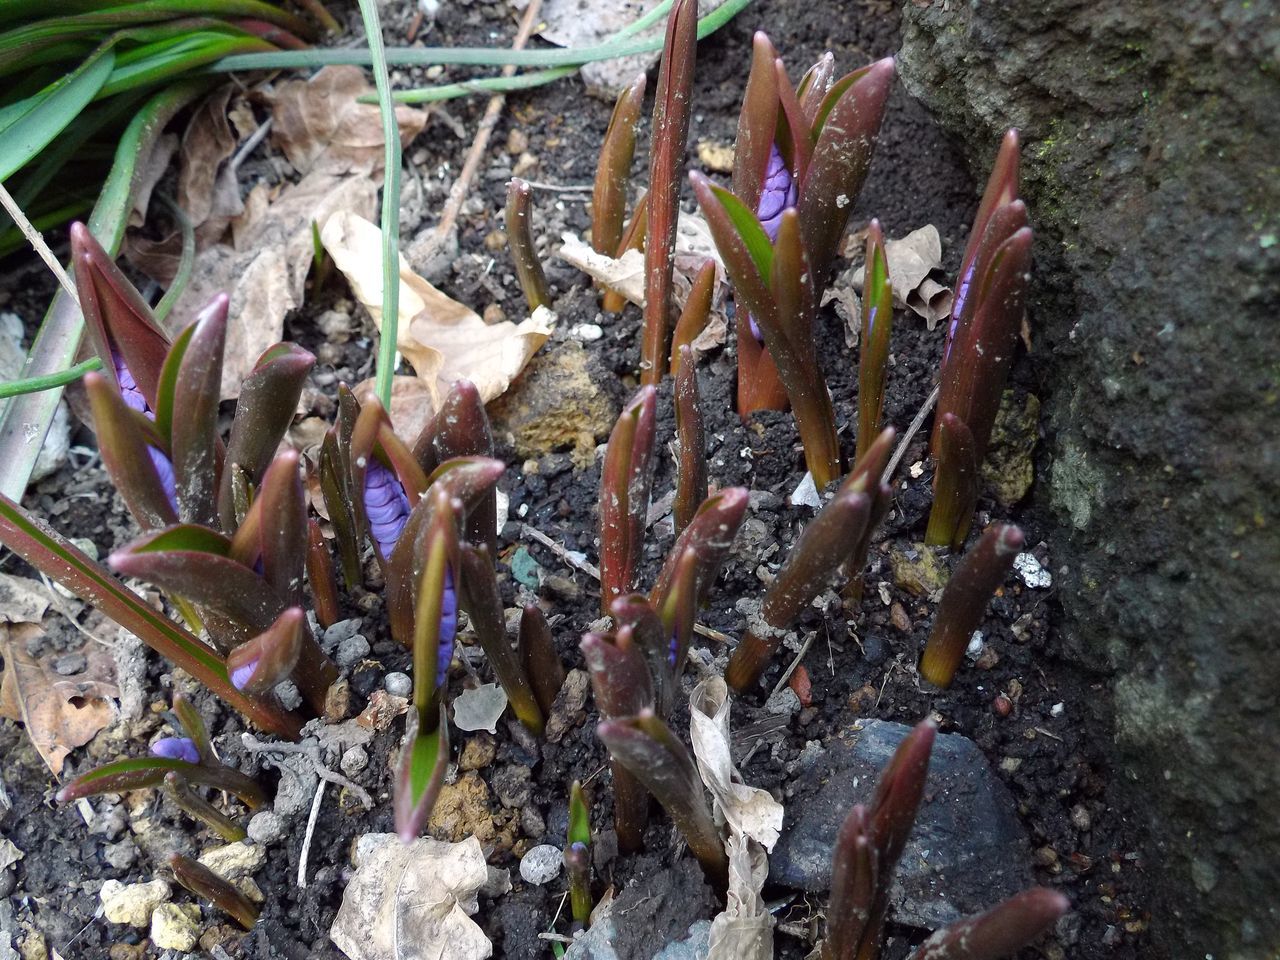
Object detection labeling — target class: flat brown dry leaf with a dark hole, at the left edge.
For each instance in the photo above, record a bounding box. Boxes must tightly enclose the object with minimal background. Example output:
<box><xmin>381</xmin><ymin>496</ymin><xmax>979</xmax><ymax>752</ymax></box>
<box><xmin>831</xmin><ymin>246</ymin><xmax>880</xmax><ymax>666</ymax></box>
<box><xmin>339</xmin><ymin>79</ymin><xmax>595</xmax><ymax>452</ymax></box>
<box><xmin>0</xmin><ymin>623</ymin><xmax>119</xmax><ymax>776</ymax></box>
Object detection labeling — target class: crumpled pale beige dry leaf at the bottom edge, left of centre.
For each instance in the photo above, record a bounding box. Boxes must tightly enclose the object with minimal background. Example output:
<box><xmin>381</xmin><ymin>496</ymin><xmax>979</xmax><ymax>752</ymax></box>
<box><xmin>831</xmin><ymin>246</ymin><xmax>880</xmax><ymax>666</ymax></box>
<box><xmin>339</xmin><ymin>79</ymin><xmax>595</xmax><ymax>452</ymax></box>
<box><xmin>329</xmin><ymin>833</ymin><xmax>493</xmax><ymax>960</ymax></box>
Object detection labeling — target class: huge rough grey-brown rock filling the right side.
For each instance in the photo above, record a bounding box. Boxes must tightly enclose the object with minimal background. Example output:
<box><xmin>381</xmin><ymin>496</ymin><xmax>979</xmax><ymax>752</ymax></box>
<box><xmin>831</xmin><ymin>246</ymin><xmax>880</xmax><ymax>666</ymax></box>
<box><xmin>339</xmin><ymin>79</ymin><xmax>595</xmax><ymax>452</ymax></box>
<box><xmin>900</xmin><ymin>0</ymin><xmax>1280</xmax><ymax>960</ymax></box>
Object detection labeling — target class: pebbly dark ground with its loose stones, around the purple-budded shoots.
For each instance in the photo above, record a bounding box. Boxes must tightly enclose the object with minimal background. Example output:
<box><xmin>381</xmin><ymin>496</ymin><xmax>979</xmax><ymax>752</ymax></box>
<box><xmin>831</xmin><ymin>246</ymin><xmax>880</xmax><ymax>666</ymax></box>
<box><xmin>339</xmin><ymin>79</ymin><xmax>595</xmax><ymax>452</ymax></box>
<box><xmin>0</xmin><ymin>0</ymin><xmax>1147</xmax><ymax>960</ymax></box>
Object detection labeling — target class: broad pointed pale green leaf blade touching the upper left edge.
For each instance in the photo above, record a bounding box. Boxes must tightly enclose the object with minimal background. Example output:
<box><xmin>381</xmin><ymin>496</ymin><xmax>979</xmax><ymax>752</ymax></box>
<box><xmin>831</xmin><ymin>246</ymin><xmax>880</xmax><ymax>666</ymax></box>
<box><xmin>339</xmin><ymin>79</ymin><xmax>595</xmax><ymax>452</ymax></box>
<box><xmin>0</xmin><ymin>45</ymin><xmax>115</xmax><ymax>180</ymax></box>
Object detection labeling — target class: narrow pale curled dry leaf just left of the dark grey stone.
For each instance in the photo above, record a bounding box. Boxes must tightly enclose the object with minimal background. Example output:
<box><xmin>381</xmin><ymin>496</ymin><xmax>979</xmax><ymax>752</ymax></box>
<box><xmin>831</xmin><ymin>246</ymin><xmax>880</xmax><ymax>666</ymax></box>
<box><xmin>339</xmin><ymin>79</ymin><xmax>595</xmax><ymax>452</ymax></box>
<box><xmin>689</xmin><ymin>677</ymin><xmax>782</xmax><ymax>850</ymax></box>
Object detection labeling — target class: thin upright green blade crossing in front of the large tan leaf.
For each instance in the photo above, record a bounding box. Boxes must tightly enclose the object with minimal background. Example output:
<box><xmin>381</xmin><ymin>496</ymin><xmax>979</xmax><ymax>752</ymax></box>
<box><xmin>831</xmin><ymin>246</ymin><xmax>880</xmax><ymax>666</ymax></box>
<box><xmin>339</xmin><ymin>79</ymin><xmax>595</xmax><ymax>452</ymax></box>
<box><xmin>358</xmin><ymin>0</ymin><xmax>401</xmax><ymax>410</ymax></box>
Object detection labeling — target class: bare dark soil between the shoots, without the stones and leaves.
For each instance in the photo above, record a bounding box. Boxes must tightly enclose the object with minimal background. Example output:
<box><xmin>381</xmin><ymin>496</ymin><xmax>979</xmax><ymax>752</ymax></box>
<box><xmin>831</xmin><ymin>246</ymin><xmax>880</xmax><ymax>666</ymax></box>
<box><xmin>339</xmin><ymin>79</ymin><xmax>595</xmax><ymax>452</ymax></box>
<box><xmin>0</xmin><ymin>0</ymin><xmax>1144</xmax><ymax>960</ymax></box>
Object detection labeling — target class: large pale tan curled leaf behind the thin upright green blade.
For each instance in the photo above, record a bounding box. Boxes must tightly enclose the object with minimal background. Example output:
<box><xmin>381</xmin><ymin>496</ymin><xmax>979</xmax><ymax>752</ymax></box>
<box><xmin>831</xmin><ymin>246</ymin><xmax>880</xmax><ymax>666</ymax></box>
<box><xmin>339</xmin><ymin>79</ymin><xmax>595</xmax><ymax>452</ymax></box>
<box><xmin>320</xmin><ymin>211</ymin><xmax>556</xmax><ymax>408</ymax></box>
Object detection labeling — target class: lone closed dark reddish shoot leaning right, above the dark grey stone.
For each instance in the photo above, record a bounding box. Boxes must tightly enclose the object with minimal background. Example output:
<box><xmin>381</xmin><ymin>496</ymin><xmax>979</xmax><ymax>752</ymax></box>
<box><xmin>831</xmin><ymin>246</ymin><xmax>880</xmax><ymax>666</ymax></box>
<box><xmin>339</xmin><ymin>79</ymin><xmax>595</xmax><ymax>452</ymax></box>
<box><xmin>920</xmin><ymin>524</ymin><xmax>1023</xmax><ymax>689</ymax></box>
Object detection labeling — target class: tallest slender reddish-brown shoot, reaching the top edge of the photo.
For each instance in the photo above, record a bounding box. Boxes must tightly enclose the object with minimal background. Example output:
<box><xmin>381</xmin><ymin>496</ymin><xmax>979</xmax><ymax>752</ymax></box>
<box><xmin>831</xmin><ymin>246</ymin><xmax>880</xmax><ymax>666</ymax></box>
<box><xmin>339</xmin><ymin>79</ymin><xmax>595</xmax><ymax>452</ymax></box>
<box><xmin>640</xmin><ymin>0</ymin><xmax>698</xmax><ymax>385</ymax></box>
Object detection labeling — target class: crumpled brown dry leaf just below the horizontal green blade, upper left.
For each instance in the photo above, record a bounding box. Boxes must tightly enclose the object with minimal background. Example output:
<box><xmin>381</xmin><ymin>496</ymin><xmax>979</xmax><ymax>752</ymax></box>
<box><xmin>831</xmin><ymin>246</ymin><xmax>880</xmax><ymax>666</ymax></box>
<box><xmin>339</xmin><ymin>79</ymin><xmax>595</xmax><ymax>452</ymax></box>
<box><xmin>271</xmin><ymin>67</ymin><xmax>426</xmax><ymax>175</ymax></box>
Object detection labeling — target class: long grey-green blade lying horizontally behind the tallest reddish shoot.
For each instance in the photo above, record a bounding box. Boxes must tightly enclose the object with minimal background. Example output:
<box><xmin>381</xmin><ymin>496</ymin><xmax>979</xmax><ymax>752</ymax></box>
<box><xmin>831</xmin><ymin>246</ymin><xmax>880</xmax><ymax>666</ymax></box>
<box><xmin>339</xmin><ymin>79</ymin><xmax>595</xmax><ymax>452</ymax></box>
<box><xmin>210</xmin><ymin>0</ymin><xmax>751</xmax><ymax>73</ymax></box>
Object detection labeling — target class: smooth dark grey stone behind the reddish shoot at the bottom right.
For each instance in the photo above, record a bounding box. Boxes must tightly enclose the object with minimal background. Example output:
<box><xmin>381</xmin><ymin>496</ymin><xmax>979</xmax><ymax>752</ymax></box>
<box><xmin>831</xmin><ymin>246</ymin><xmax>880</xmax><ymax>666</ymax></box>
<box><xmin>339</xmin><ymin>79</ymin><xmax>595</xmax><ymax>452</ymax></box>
<box><xmin>769</xmin><ymin>721</ymin><xmax>1032</xmax><ymax>929</ymax></box>
